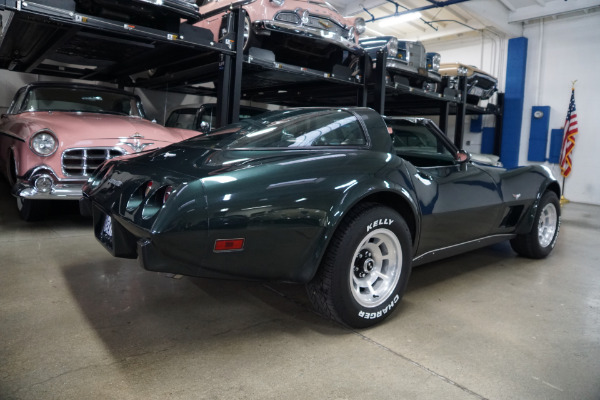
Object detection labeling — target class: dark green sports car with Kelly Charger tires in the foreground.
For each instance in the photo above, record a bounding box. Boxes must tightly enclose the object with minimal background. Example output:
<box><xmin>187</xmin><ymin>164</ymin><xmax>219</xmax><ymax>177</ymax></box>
<box><xmin>81</xmin><ymin>108</ymin><xmax>560</xmax><ymax>327</ymax></box>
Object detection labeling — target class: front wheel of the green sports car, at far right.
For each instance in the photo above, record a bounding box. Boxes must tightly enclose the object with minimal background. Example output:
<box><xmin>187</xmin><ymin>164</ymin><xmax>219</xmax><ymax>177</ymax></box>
<box><xmin>510</xmin><ymin>192</ymin><xmax>560</xmax><ymax>259</ymax></box>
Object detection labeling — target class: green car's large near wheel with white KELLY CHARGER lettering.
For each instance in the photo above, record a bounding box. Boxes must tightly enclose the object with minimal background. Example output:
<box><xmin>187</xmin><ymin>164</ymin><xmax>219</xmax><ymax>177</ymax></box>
<box><xmin>307</xmin><ymin>204</ymin><xmax>412</xmax><ymax>328</ymax></box>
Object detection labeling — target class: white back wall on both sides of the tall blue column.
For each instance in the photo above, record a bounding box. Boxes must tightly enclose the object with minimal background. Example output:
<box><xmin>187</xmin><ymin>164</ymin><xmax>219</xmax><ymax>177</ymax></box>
<box><xmin>425</xmin><ymin>12</ymin><xmax>600</xmax><ymax>204</ymax></box>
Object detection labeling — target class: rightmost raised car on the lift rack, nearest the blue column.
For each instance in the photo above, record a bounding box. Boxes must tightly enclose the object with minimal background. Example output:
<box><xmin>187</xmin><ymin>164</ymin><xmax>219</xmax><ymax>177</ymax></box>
<box><xmin>440</xmin><ymin>63</ymin><xmax>498</xmax><ymax>105</ymax></box>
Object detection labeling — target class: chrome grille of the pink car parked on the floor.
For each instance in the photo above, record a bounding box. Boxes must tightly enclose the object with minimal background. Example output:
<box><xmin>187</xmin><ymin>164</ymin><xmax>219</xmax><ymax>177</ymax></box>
<box><xmin>62</xmin><ymin>147</ymin><xmax>125</xmax><ymax>177</ymax></box>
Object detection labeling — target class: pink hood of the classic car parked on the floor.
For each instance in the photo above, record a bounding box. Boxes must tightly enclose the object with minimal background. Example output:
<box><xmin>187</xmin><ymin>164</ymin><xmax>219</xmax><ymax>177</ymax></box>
<box><xmin>14</xmin><ymin>112</ymin><xmax>192</xmax><ymax>143</ymax></box>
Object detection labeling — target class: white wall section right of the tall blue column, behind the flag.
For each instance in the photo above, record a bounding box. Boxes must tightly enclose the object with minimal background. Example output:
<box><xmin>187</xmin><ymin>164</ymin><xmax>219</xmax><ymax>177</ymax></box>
<box><xmin>519</xmin><ymin>12</ymin><xmax>600</xmax><ymax>204</ymax></box>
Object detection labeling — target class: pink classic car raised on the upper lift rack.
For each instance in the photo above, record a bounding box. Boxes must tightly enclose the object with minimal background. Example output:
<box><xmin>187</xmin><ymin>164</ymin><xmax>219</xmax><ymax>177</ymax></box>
<box><xmin>195</xmin><ymin>0</ymin><xmax>365</xmax><ymax>69</ymax></box>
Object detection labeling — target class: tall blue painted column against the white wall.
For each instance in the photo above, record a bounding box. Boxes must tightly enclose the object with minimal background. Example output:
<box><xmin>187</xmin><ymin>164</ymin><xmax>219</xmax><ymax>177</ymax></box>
<box><xmin>500</xmin><ymin>37</ymin><xmax>527</xmax><ymax>168</ymax></box>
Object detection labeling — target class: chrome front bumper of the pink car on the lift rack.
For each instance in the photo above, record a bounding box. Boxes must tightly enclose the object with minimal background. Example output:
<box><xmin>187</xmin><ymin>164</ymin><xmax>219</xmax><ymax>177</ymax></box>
<box><xmin>252</xmin><ymin>20</ymin><xmax>363</xmax><ymax>53</ymax></box>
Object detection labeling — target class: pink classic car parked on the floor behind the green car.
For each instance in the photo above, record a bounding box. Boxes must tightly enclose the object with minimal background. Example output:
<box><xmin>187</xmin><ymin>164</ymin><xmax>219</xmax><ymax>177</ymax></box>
<box><xmin>0</xmin><ymin>82</ymin><xmax>198</xmax><ymax>221</ymax></box>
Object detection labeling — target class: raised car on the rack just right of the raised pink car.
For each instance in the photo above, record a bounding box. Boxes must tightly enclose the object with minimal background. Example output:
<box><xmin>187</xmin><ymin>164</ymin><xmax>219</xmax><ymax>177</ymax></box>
<box><xmin>360</xmin><ymin>36</ymin><xmax>442</xmax><ymax>92</ymax></box>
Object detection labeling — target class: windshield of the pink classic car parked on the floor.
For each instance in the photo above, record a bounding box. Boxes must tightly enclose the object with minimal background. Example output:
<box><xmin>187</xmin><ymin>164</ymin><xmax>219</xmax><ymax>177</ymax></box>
<box><xmin>20</xmin><ymin>87</ymin><xmax>144</xmax><ymax>117</ymax></box>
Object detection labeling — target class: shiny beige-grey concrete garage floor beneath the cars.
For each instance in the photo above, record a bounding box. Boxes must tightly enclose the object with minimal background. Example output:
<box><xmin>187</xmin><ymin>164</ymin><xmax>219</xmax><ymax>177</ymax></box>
<box><xmin>0</xmin><ymin>181</ymin><xmax>600</xmax><ymax>400</ymax></box>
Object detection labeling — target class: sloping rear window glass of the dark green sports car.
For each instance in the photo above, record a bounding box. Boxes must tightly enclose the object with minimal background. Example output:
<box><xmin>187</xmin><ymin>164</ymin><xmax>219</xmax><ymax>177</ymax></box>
<box><xmin>190</xmin><ymin>108</ymin><xmax>367</xmax><ymax>149</ymax></box>
